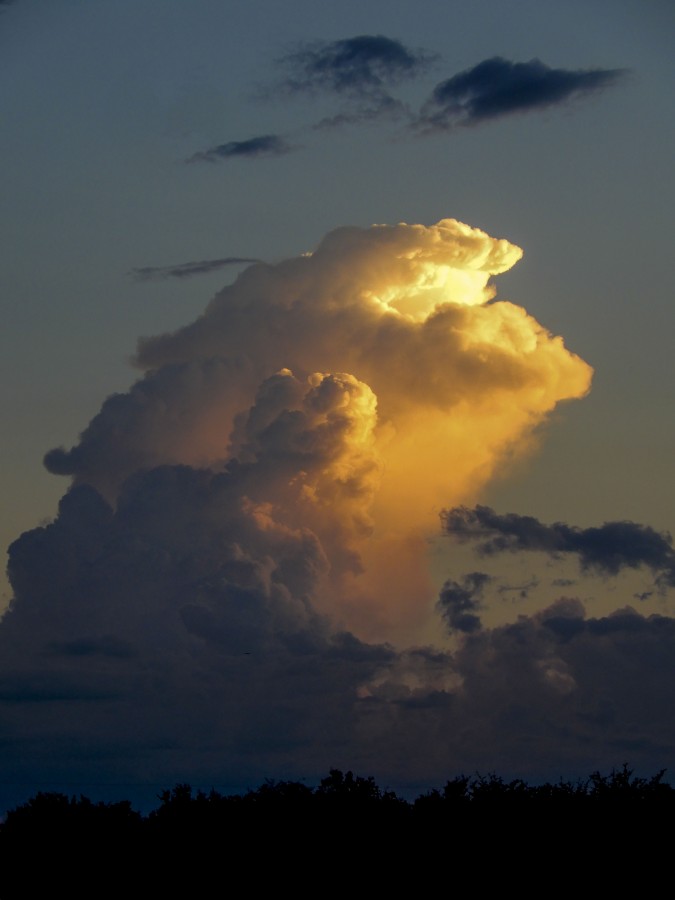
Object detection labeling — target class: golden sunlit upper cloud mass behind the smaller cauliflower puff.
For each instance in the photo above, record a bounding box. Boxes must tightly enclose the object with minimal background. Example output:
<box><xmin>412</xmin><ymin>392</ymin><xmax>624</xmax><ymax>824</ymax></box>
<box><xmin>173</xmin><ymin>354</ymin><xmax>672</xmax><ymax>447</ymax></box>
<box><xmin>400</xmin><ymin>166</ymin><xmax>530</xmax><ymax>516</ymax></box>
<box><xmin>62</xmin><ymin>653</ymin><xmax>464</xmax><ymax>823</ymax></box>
<box><xmin>45</xmin><ymin>219</ymin><xmax>591</xmax><ymax>639</ymax></box>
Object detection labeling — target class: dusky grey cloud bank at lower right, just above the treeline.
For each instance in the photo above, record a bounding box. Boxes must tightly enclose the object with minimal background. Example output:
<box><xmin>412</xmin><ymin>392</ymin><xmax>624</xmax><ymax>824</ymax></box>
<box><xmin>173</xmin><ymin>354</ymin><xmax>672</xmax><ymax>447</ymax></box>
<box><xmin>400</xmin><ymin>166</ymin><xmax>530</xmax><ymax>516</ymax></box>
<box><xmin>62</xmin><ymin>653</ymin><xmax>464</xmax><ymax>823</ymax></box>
<box><xmin>448</xmin><ymin>599</ymin><xmax>675</xmax><ymax>769</ymax></box>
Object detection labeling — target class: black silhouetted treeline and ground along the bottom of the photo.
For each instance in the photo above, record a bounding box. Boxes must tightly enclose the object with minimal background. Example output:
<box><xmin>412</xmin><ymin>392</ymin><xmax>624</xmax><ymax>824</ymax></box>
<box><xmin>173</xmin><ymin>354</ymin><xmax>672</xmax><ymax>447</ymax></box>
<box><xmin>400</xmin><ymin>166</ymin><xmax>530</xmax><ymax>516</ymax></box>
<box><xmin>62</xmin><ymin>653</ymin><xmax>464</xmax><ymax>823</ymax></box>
<box><xmin>0</xmin><ymin>767</ymin><xmax>675</xmax><ymax>900</ymax></box>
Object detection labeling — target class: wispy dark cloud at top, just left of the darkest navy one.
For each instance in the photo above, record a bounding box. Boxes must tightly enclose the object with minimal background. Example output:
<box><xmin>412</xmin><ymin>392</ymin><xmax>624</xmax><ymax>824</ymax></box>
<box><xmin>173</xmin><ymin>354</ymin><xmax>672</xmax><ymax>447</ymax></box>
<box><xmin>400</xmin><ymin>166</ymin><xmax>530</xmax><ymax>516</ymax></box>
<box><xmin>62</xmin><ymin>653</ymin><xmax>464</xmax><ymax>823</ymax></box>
<box><xmin>279</xmin><ymin>34</ymin><xmax>431</xmax><ymax>95</ymax></box>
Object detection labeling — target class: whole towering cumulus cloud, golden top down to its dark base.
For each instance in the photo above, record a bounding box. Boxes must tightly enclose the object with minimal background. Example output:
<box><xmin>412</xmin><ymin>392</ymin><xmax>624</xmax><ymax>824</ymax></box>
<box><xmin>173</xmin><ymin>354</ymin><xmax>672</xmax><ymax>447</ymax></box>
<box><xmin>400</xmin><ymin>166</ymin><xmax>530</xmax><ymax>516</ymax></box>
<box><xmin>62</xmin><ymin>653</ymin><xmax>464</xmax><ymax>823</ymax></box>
<box><xmin>0</xmin><ymin>219</ymin><xmax>604</xmax><ymax>808</ymax></box>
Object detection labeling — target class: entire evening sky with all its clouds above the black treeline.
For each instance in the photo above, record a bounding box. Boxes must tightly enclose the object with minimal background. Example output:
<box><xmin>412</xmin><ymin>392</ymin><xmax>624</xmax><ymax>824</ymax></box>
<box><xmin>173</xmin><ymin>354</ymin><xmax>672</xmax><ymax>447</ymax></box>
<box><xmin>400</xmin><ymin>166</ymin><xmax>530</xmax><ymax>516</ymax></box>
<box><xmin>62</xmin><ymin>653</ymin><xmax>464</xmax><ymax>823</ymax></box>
<box><xmin>0</xmin><ymin>0</ymin><xmax>675</xmax><ymax>809</ymax></box>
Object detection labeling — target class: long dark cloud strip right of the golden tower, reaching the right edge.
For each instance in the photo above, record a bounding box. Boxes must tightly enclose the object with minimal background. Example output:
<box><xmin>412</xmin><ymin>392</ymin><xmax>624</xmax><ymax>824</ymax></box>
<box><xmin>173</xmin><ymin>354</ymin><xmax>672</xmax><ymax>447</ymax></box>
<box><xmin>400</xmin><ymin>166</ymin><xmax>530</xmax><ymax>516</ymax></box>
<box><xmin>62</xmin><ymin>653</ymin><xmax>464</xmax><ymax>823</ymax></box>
<box><xmin>441</xmin><ymin>506</ymin><xmax>675</xmax><ymax>586</ymax></box>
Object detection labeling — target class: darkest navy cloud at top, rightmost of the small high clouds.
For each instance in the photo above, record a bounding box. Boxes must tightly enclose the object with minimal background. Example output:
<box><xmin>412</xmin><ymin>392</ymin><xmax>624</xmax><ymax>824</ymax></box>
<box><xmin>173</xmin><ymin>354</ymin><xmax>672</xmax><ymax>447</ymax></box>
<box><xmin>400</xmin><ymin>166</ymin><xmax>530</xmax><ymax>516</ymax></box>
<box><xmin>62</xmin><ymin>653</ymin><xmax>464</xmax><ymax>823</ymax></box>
<box><xmin>416</xmin><ymin>56</ymin><xmax>626</xmax><ymax>132</ymax></box>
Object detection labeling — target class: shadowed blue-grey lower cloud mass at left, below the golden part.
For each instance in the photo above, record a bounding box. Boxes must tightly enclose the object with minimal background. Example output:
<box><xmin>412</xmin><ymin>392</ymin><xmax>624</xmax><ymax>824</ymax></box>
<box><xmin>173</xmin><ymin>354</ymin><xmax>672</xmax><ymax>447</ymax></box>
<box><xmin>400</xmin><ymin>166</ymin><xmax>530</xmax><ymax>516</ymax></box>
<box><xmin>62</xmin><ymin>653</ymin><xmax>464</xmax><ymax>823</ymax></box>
<box><xmin>0</xmin><ymin>458</ymin><xmax>393</xmax><ymax>796</ymax></box>
